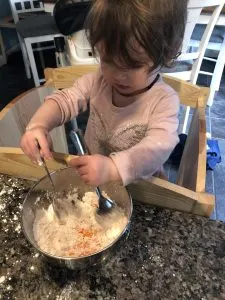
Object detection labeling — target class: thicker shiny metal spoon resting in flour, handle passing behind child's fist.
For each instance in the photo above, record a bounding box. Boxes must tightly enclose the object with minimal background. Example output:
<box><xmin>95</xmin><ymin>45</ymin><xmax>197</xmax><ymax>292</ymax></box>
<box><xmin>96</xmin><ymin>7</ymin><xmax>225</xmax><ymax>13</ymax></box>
<box><xmin>70</xmin><ymin>130</ymin><xmax>115</xmax><ymax>214</ymax></box>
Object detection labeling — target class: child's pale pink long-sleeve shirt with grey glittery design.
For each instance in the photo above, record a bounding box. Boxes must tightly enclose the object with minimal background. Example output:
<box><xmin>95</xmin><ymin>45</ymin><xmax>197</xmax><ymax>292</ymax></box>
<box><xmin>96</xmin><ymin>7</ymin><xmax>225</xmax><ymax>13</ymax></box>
<box><xmin>46</xmin><ymin>71</ymin><xmax>179</xmax><ymax>185</ymax></box>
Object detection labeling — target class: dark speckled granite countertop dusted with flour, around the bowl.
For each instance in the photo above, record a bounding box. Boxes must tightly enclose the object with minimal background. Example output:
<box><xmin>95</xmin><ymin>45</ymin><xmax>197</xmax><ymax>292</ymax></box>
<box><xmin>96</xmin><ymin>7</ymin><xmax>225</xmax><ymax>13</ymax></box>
<box><xmin>0</xmin><ymin>175</ymin><xmax>225</xmax><ymax>300</ymax></box>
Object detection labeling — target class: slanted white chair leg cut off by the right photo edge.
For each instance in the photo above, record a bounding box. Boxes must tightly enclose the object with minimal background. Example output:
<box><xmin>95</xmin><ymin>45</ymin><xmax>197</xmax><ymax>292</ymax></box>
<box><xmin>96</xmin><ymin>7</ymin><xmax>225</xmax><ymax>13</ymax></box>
<box><xmin>207</xmin><ymin>37</ymin><xmax>225</xmax><ymax>106</ymax></box>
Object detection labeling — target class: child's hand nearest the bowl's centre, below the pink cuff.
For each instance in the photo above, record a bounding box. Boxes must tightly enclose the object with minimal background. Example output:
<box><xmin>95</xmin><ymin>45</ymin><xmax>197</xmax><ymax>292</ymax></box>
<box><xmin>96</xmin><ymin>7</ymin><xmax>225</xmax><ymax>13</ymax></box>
<box><xmin>69</xmin><ymin>154</ymin><xmax>121</xmax><ymax>186</ymax></box>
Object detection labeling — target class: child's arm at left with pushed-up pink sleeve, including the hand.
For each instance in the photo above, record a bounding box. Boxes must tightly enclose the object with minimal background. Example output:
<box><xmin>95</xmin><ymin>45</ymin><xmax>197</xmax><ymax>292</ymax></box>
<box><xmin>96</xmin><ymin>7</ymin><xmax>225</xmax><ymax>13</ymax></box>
<box><xmin>20</xmin><ymin>73</ymin><xmax>96</xmax><ymax>162</ymax></box>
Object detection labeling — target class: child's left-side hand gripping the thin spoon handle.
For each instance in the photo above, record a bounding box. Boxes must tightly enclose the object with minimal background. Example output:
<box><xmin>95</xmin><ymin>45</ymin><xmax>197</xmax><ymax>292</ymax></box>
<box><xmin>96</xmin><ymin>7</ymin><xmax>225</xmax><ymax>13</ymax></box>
<box><xmin>20</xmin><ymin>127</ymin><xmax>52</xmax><ymax>163</ymax></box>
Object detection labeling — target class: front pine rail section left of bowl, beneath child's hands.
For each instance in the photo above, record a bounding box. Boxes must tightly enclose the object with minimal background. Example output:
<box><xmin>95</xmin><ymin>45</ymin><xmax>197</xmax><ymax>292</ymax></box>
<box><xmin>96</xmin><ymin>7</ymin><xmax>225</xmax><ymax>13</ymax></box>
<box><xmin>0</xmin><ymin>147</ymin><xmax>75</xmax><ymax>180</ymax></box>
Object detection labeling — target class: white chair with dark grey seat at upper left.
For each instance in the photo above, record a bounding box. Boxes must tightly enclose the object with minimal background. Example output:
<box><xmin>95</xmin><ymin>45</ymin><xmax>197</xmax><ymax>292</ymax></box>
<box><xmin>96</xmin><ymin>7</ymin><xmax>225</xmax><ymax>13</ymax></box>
<box><xmin>9</xmin><ymin>0</ymin><xmax>61</xmax><ymax>87</ymax></box>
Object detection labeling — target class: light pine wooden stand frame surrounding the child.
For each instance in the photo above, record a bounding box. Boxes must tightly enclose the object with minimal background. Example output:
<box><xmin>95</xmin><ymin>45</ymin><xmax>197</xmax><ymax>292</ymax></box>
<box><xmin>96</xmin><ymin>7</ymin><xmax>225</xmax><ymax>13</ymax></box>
<box><xmin>0</xmin><ymin>65</ymin><xmax>215</xmax><ymax>216</ymax></box>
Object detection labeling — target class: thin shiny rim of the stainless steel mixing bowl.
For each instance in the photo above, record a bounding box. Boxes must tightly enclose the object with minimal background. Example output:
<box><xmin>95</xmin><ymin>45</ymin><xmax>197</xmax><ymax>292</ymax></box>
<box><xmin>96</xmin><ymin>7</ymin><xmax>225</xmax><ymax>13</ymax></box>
<box><xmin>21</xmin><ymin>167</ymin><xmax>133</xmax><ymax>260</ymax></box>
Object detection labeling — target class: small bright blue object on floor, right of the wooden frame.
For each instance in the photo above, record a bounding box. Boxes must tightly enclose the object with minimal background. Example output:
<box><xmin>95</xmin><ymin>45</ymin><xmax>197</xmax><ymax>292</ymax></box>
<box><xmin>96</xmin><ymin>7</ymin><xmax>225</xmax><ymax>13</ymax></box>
<box><xmin>207</xmin><ymin>140</ymin><xmax>221</xmax><ymax>170</ymax></box>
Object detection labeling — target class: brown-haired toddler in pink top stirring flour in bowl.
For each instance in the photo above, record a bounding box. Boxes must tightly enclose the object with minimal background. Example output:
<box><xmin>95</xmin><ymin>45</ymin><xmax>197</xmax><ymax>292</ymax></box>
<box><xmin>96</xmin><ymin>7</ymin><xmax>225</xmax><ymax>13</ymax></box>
<box><xmin>21</xmin><ymin>0</ymin><xmax>187</xmax><ymax>185</ymax></box>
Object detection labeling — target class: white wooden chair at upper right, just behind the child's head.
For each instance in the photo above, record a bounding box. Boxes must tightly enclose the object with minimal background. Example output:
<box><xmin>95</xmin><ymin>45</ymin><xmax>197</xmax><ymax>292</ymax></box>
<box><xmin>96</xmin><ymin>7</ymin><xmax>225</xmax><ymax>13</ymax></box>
<box><xmin>162</xmin><ymin>0</ymin><xmax>225</xmax><ymax>133</ymax></box>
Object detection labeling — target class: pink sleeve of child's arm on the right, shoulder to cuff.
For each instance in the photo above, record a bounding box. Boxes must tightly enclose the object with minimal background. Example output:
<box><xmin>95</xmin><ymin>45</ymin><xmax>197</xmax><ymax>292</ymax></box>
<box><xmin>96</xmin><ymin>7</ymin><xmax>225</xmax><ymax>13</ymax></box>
<box><xmin>110</xmin><ymin>93</ymin><xmax>179</xmax><ymax>185</ymax></box>
